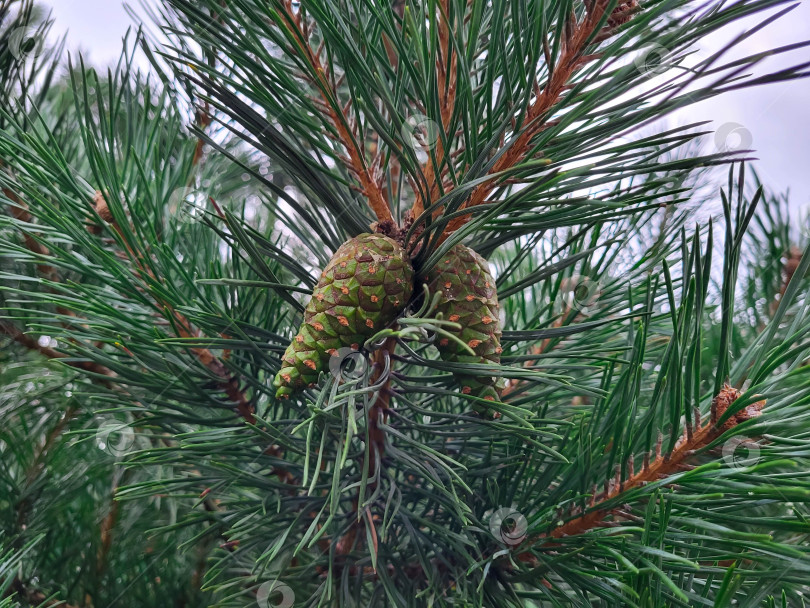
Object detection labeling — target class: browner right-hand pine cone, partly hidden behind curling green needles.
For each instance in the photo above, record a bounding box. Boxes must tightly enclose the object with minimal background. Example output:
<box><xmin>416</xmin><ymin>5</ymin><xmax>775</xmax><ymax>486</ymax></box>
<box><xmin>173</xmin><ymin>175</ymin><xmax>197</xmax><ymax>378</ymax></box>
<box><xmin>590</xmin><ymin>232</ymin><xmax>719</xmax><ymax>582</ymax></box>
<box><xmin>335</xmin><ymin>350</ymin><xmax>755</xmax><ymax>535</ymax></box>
<box><xmin>424</xmin><ymin>244</ymin><xmax>502</xmax><ymax>416</ymax></box>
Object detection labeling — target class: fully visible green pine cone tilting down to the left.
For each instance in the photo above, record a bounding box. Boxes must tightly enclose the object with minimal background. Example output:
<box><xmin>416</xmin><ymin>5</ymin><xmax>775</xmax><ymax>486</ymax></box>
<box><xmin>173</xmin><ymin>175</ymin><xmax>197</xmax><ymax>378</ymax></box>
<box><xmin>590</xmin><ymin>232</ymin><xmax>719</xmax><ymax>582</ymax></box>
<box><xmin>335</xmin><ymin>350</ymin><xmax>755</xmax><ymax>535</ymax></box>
<box><xmin>273</xmin><ymin>233</ymin><xmax>413</xmax><ymax>399</ymax></box>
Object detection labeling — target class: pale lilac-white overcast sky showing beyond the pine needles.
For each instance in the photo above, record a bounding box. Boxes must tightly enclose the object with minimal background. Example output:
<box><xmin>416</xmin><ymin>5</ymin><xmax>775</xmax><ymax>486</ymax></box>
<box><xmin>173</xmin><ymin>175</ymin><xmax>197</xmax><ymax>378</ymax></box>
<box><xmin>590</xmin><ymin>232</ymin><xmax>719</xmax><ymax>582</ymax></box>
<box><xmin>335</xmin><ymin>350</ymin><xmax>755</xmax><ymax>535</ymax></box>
<box><xmin>45</xmin><ymin>0</ymin><xmax>810</xmax><ymax>215</ymax></box>
